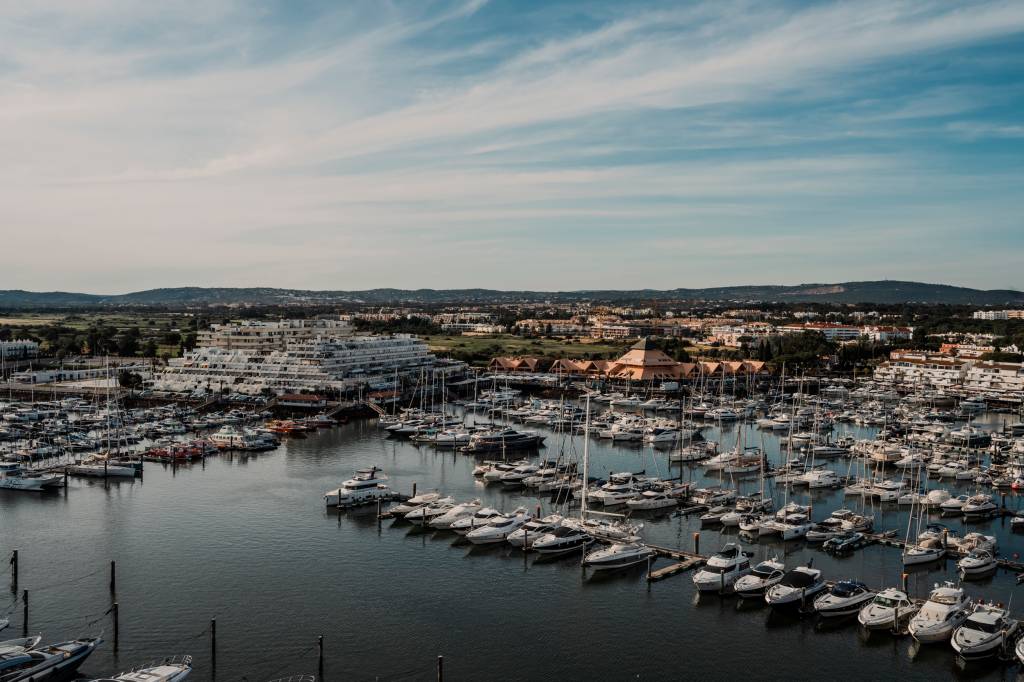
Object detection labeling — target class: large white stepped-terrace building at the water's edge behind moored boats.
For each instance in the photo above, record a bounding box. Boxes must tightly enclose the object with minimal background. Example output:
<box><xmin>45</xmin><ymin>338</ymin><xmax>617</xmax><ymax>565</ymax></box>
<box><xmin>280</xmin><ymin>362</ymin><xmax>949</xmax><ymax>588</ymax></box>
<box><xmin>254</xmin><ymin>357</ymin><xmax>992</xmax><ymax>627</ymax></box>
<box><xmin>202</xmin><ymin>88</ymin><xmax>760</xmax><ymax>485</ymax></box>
<box><xmin>153</xmin><ymin>335</ymin><xmax>465</xmax><ymax>393</ymax></box>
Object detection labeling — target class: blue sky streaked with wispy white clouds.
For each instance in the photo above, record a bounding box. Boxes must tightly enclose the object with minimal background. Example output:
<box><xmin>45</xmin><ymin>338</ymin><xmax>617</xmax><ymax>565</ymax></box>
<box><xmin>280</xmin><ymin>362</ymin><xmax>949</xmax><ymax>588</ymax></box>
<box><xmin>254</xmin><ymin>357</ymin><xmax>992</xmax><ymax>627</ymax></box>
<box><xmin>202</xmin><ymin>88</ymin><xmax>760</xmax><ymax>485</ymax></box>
<box><xmin>0</xmin><ymin>0</ymin><xmax>1024</xmax><ymax>294</ymax></box>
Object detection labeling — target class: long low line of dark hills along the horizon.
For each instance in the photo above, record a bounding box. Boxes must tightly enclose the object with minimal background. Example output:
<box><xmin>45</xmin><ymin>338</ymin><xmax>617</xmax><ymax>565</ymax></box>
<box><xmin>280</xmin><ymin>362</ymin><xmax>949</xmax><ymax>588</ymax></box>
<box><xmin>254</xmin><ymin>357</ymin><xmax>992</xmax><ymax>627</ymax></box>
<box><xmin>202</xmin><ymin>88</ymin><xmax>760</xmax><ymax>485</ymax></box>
<box><xmin>0</xmin><ymin>281</ymin><xmax>1024</xmax><ymax>309</ymax></box>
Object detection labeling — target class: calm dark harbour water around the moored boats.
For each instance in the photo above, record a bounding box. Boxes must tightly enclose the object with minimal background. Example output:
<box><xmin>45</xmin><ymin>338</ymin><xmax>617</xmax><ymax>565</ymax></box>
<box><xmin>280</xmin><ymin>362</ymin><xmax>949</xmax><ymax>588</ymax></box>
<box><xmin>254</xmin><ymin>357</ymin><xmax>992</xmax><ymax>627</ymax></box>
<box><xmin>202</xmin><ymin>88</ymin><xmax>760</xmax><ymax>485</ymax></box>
<box><xmin>6</xmin><ymin>405</ymin><xmax>1024</xmax><ymax>680</ymax></box>
